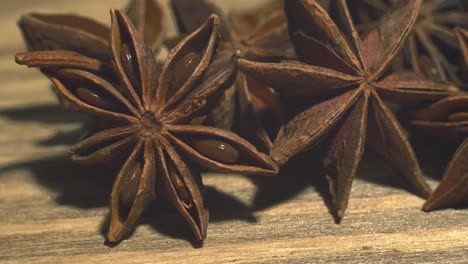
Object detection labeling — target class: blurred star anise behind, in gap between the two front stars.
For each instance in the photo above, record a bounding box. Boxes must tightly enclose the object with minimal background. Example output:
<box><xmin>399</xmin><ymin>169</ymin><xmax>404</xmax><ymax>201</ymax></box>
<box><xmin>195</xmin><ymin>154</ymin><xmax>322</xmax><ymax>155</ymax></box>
<box><xmin>171</xmin><ymin>0</ymin><xmax>294</xmax><ymax>151</ymax></box>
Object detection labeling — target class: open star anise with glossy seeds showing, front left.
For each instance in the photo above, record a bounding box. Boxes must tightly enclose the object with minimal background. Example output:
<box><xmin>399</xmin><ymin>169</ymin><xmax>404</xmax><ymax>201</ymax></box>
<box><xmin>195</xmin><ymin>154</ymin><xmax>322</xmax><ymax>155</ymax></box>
<box><xmin>16</xmin><ymin>10</ymin><xmax>277</xmax><ymax>242</ymax></box>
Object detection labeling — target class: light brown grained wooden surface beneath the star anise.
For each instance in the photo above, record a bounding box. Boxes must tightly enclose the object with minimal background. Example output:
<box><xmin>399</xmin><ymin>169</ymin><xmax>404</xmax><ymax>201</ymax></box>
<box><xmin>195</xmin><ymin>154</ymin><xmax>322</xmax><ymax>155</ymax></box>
<box><xmin>0</xmin><ymin>0</ymin><xmax>468</xmax><ymax>263</ymax></box>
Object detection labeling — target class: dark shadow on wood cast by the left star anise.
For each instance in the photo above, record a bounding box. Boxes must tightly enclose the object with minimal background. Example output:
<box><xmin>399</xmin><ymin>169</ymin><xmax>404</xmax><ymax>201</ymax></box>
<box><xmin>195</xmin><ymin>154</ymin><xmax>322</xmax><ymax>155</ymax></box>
<box><xmin>0</xmin><ymin>155</ymin><xmax>257</xmax><ymax>247</ymax></box>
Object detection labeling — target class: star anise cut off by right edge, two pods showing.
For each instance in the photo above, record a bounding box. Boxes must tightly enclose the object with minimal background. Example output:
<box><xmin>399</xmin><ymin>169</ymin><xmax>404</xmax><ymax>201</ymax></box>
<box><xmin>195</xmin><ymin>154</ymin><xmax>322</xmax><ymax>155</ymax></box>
<box><xmin>401</xmin><ymin>94</ymin><xmax>468</xmax><ymax>211</ymax></box>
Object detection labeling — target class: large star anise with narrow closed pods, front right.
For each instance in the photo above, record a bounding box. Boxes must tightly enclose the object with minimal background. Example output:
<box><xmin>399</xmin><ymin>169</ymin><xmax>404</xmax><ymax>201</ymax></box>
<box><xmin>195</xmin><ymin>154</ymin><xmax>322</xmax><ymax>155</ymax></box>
<box><xmin>239</xmin><ymin>0</ymin><xmax>457</xmax><ymax>218</ymax></box>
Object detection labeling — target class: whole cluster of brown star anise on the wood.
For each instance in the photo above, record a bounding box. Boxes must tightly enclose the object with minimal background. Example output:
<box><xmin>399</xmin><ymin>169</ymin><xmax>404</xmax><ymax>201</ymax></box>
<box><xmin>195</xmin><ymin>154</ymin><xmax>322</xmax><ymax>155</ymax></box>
<box><xmin>16</xmin><ymin>0</ymin><xmax>468</xmax><ymax>242</ymax></box>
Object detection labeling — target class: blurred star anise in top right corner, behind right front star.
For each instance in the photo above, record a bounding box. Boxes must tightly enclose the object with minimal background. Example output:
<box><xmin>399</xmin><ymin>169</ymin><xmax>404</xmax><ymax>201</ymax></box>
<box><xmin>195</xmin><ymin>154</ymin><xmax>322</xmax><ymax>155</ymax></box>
<box><xmin>352</xmin><ymin>0</ymin><xmax>468</xmax><ymax>86</ymax></box>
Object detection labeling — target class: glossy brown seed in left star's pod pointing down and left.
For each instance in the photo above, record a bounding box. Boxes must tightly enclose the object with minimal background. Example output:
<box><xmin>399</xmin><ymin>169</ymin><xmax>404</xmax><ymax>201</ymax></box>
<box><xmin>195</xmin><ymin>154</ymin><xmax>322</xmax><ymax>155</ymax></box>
<box><xmin>119</xmin><ymin>162</ymin><xmax>142</xmax><ymax>208</ymax></box>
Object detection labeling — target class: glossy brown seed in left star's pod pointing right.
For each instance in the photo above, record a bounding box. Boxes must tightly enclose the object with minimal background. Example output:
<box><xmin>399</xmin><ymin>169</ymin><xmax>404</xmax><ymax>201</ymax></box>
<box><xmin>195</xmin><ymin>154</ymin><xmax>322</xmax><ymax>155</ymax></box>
<box><xmin>192</xmin><ymin>139</ymin><xmax>240</xmax><ymax>164</ymax></box>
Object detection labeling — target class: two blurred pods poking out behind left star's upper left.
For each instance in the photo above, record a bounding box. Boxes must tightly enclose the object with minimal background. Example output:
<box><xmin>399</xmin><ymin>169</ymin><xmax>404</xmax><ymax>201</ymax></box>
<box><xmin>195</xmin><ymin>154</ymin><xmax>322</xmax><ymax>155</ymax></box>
<box><xmin>18</xmin><ymin>0</ymin><xmax>166</xmax><ymax>64</ymax></box>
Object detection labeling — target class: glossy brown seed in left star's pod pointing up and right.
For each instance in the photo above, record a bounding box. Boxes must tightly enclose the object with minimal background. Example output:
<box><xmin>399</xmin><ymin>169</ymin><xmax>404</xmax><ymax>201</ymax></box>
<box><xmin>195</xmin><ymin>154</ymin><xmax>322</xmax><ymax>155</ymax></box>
<box><xmin>168</xmin><ymin>51</ymin><xmax>201</xmax><ymax>96</ymax></box>
